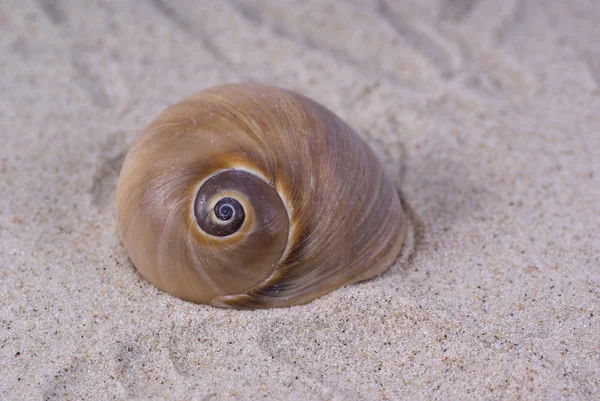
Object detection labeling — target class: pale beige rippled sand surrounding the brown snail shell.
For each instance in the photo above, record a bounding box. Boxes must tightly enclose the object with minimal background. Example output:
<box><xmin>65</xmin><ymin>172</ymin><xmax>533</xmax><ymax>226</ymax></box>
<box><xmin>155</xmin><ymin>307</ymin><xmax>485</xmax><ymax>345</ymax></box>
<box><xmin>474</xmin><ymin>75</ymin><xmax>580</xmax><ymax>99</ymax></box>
<box><xmin>0</xmin><ymin>0</ymin><xmax>600</xmax><ymax>400</ymax></box>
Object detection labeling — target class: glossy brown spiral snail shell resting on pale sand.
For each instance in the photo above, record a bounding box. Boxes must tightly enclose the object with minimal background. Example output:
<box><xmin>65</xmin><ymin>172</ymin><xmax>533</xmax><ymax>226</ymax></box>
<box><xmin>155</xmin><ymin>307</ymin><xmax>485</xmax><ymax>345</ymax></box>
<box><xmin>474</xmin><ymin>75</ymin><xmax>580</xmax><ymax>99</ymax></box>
<box><xmin>116</xmin><ymin>84</ymin><xmax>405</xmax><ymax>309</ymax></box>
